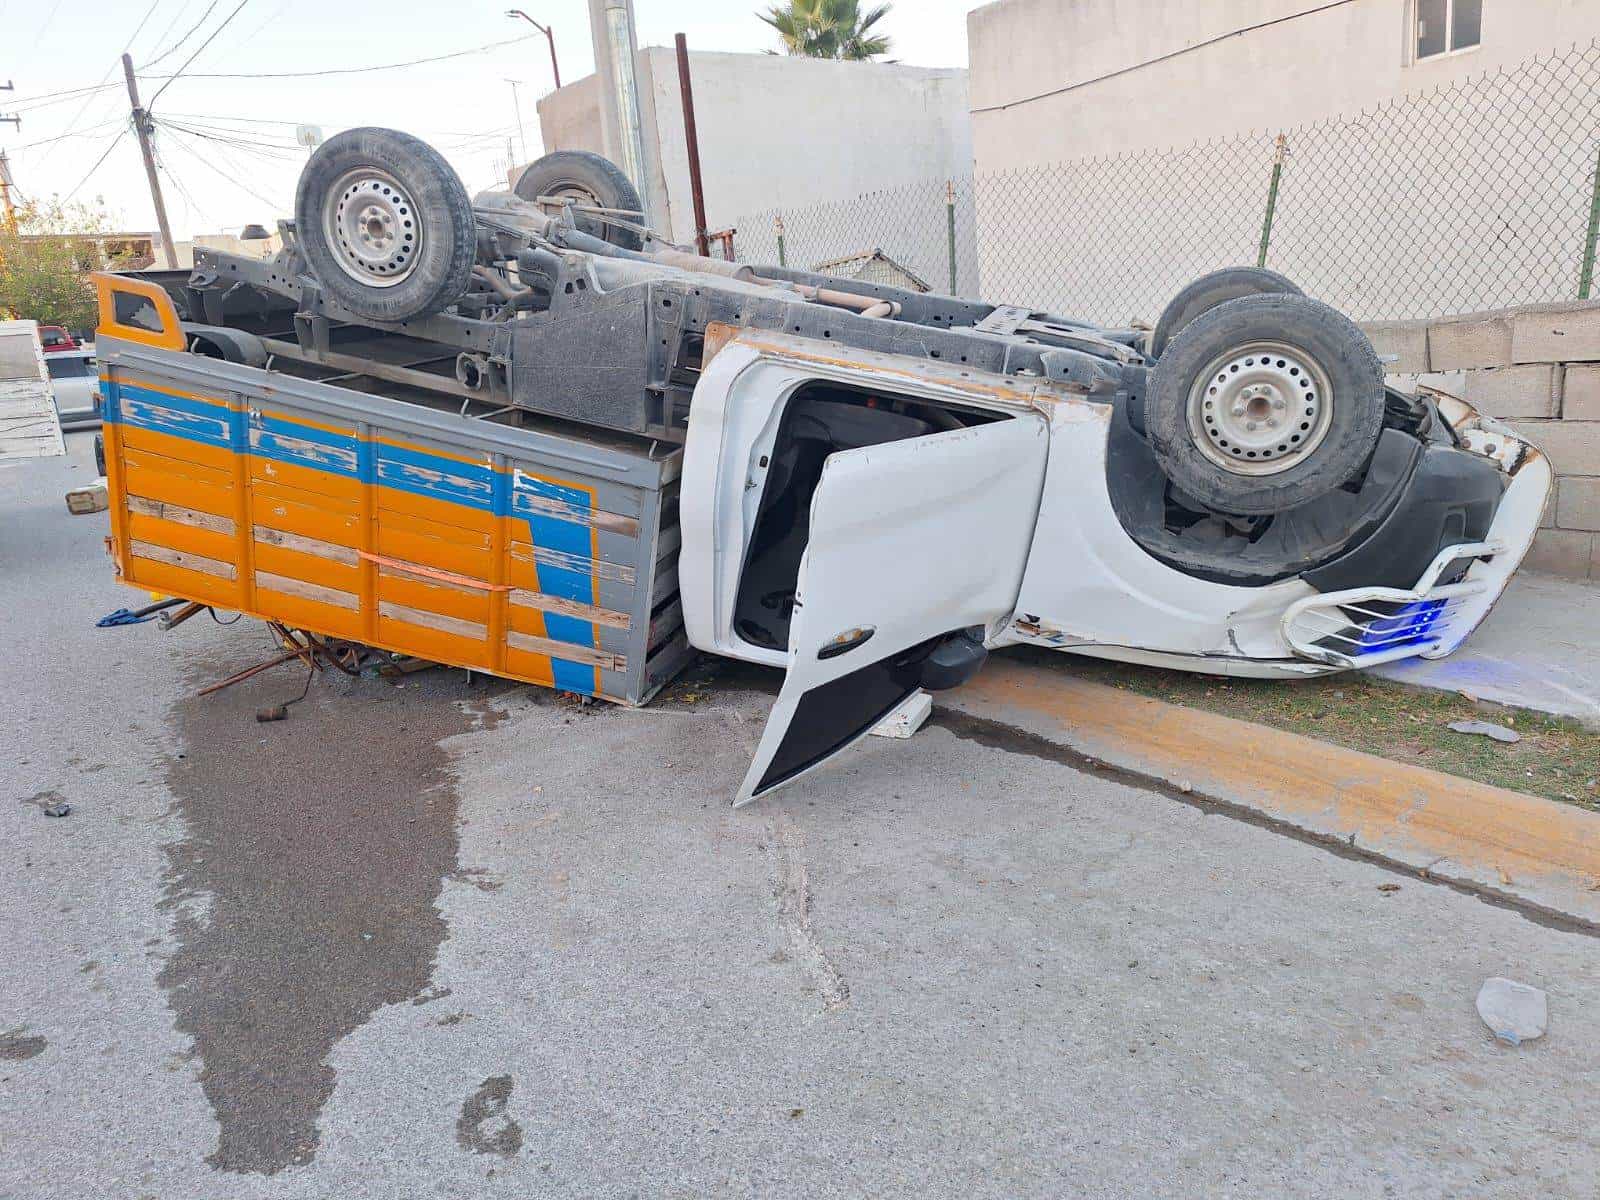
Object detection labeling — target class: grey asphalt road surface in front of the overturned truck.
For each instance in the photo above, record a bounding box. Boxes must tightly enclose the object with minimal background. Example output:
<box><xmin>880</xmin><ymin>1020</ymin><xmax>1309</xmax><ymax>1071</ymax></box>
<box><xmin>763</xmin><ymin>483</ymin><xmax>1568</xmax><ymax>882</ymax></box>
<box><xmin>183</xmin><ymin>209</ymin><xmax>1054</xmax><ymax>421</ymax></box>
<box><xmin>0</xmin><ymin>434</ymin><xmax>1600</xmax><ymax>1200</ymax></box>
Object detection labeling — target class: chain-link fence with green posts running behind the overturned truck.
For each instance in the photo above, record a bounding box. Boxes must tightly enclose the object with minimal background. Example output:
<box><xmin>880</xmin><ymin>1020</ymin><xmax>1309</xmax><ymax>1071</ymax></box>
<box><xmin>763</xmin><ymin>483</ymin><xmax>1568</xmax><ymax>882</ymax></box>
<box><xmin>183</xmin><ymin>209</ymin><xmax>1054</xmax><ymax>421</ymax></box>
<box><xmin>738</xmin><ymin>42</ymin><xmax>1600</xmax><ymax>323</ymax></box>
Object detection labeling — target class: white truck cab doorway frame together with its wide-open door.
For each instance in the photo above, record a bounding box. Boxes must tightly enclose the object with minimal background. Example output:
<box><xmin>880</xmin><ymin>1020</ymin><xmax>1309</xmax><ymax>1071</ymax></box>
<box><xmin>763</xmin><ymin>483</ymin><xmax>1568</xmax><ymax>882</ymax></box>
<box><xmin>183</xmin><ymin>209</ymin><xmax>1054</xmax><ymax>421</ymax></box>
<box><xmin>668</xmin><ymin>336</ymin><xmax>1050</xmax><ymax>803</ymax></box>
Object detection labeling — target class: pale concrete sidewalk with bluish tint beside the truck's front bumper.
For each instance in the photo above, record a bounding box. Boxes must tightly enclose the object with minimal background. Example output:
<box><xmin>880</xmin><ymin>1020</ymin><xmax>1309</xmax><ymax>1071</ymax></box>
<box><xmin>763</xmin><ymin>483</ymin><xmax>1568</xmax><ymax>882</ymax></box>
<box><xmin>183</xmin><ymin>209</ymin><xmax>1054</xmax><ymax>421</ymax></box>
<box><xmin>1374</xmin><ymin>571</ymin><xmax>1600</xmax><ymax>726</ymax></box>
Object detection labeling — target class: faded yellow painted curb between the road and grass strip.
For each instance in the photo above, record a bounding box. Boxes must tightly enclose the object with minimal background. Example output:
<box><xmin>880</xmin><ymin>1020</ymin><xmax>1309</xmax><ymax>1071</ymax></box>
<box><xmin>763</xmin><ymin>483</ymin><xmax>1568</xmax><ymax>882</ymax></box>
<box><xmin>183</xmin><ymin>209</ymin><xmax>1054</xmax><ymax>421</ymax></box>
<box><xmin>939</xmin><ymin>659</ymin><xmax>1600</xmax><ymax>918</ymax></box>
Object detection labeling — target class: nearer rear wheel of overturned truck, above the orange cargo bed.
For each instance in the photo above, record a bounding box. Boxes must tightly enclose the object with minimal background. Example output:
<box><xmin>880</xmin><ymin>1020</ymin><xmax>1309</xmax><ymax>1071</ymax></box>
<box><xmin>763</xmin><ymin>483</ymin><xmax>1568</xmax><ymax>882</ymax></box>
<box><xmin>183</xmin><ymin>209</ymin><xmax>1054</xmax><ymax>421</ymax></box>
<box><xmin>294</xmin><ymin>128</ymin><xmax>478</xmax><ymax>322</ymax></box>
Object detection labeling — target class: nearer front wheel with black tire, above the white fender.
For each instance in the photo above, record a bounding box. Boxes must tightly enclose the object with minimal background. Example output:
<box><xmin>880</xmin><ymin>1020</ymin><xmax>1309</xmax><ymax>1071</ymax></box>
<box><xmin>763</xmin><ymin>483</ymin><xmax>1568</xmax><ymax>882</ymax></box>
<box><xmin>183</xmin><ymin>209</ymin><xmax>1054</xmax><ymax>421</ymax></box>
<box><xmin>1146</xmin><ymin>294</ymin><xmax>1384</xmax><ymax>517</ymax></box>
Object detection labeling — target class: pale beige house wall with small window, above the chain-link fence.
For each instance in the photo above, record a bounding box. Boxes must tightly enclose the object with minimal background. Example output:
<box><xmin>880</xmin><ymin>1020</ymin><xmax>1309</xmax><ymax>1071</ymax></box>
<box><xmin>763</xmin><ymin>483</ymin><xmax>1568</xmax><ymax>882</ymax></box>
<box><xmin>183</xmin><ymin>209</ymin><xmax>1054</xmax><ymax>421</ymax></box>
<box><xmin>966</xmin><ymin>0</ymin><xmax>1600</xmax><ymax>174</ymax></box>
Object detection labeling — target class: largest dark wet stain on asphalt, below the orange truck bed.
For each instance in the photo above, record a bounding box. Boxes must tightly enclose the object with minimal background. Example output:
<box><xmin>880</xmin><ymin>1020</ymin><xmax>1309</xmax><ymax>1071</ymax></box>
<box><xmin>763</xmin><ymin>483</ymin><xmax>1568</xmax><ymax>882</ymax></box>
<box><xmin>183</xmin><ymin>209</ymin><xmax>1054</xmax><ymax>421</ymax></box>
<box><xmin>160</xmin><ymin>667</ymin><xmax>499</xmax><ymax>1174</ymax></box>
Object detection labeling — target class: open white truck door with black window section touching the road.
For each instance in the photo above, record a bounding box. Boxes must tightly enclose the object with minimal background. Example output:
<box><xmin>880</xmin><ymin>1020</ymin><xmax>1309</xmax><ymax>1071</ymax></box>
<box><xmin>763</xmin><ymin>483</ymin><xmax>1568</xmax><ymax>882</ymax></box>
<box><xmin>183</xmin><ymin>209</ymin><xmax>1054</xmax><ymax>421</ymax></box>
<box><xmin>734</xmin><ymin>413</ymin><xmax>1046</xmax><ymax>803</ymax></box>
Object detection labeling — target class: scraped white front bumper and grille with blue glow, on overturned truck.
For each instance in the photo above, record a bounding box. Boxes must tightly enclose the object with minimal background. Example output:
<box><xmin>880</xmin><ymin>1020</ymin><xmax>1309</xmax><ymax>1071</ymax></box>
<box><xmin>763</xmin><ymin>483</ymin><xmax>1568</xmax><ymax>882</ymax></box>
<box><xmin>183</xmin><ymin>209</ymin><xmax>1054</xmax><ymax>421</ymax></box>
<box><xmin>1280</xmin><ymin>394</ymin><xmax>1552</xmax><ymax>667</ymax></box>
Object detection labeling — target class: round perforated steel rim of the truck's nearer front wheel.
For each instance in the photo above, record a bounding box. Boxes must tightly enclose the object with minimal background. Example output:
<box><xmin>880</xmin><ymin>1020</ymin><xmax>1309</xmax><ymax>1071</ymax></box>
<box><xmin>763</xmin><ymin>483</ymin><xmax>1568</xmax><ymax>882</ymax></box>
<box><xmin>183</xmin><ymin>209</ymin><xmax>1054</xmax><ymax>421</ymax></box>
<box><xmin>1187</xmin><ymin>342</ymin><xmax>1334</xmax><ymax>475</ymax></box>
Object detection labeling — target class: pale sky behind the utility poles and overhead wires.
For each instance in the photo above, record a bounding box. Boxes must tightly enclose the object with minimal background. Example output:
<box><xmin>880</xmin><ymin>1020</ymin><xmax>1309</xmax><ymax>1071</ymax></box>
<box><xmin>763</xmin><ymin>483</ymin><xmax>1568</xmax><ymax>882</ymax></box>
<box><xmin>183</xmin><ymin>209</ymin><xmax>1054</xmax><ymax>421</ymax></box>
<box><xmin>0</xmin><ymin>0</ymin><xmax>979</xmax><ymax>240</ymax></box>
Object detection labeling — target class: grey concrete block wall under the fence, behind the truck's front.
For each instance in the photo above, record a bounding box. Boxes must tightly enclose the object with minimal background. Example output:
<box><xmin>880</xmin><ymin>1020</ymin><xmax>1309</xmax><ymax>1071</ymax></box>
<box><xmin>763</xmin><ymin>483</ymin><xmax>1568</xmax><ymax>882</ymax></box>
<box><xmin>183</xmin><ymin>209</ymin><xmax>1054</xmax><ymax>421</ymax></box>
<box><xmin>1362</xmin><ymin>302</ymin><xmax>1600</xmax><ymax>586</ymax></box>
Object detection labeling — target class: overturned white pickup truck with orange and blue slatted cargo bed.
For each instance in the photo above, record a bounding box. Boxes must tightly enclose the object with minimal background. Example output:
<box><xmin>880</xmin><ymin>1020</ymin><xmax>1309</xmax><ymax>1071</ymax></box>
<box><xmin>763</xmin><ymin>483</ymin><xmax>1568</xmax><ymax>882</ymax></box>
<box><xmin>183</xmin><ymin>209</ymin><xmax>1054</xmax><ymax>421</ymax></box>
<box><xmin>99</xmin><ymin>130</ymin><xmax>1550</xmax><ymax>798</ymax></box>
